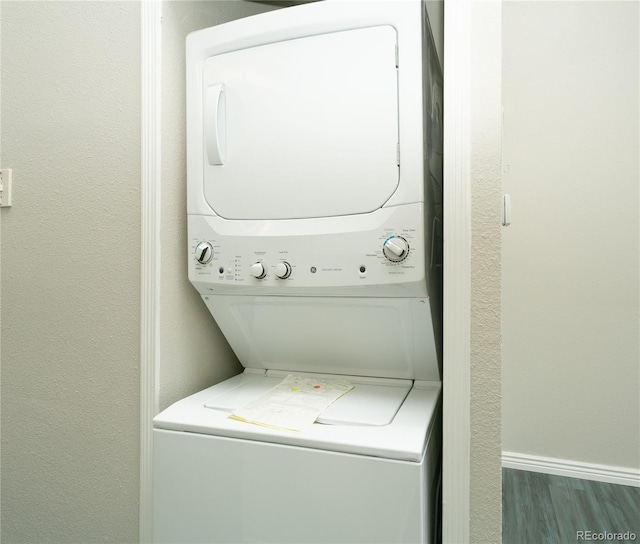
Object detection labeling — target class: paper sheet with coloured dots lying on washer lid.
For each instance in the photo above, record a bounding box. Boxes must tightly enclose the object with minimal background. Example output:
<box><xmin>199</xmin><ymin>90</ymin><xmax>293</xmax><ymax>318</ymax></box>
<box><xmin>229</xmin><ymin>374</ymin><xmax>353</xmax><ymax>432</ymax></box>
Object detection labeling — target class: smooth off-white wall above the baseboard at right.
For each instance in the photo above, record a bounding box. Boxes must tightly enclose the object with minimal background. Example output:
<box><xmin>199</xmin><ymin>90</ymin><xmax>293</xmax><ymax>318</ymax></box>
<box><xmin>502</xmin><ymin>1</ymin><xmax>640</xmax><ymax>476</ymax></box>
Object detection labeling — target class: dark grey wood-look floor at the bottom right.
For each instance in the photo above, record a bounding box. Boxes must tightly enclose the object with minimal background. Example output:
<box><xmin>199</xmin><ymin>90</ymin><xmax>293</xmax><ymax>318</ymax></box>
<box><xmin>502</xmin><ymin>468</ymin><xmax>640</xmax><ymax>544</ymax></box>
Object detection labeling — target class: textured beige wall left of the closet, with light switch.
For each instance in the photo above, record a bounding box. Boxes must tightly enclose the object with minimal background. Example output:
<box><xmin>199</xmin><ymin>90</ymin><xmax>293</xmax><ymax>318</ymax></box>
<box><xmin>1</xmin><ymin>2</ymin><xmax>140</xmax><ymax>544</ymax></box>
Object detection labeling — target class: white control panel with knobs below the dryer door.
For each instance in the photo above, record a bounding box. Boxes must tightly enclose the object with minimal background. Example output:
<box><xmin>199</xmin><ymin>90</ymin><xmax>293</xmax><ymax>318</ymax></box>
<box><xmin>189</xmin><ymin>204</ymin><xmax>427</xmax><ymax>296</ymax></box>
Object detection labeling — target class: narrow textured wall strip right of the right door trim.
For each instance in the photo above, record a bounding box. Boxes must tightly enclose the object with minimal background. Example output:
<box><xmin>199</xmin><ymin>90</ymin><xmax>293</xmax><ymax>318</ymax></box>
<box><xmin>469</xmin><ymin>2</ymin><xmax>502</xmax><ymax>543</ymax></box>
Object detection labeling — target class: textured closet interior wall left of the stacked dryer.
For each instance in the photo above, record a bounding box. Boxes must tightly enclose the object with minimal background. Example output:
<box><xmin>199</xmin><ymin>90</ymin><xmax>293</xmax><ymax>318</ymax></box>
<box><xmin>159</xmin><ymin>0</ymin><xmax>274</xmax><ymax>410</ymax></box>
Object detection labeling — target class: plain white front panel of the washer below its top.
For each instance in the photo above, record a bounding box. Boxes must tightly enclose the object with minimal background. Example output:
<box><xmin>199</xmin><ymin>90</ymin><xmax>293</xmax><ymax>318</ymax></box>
<box><xmin>153</xmin><ymin>429</ymin><xmax>434</xmax><ymax>544</ymax></box>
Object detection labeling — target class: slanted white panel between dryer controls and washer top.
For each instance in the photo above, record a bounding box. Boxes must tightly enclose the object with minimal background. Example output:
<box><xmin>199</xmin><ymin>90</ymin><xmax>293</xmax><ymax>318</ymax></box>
<box><xmin>203</xmin><ymin>295</ymin><xmax>440</xmax><ymax>381</ymax></box>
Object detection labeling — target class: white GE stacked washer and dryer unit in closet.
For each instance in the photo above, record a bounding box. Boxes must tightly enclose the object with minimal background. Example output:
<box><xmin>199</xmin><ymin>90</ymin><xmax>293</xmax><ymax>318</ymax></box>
<box><xmin>153</xmin><ymin>0</ymin><xmax>442</xmax><ymax>544</ymax></box>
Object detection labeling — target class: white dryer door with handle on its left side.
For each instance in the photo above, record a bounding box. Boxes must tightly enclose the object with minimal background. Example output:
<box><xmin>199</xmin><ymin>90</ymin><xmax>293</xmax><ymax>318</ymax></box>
<box><xmin>203</xmin><ymin>25</ymin><xmax>399</xmax><ymax>219</ymax></box>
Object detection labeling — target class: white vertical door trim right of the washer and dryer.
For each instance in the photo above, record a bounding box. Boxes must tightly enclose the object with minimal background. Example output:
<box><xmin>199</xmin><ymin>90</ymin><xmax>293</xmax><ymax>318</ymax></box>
<box><xmin>442</xmin><ymin>0</ymin><xmax>473</xmax><ymax>544</ymax></box>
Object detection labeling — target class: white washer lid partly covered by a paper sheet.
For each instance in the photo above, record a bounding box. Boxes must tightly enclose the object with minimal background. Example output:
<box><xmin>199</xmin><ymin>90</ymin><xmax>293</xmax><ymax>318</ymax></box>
<box><xmin>205</xmin><ymin>370</ymin><xmax>413</xmax><ymax>426</ymax></box>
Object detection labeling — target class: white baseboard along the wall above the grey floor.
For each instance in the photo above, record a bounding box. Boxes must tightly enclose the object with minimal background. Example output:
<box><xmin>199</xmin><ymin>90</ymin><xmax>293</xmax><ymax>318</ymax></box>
<box><xmin>502</xmin><ymin>451</ymin><xmax>640</xmax><ymax>487</ymax></box>
